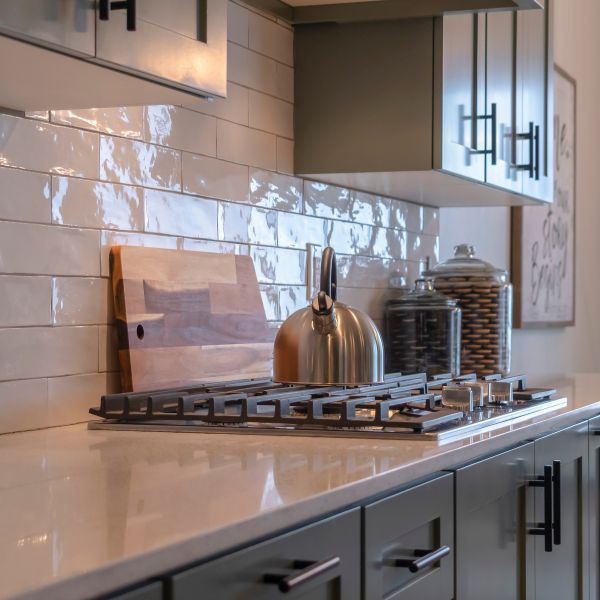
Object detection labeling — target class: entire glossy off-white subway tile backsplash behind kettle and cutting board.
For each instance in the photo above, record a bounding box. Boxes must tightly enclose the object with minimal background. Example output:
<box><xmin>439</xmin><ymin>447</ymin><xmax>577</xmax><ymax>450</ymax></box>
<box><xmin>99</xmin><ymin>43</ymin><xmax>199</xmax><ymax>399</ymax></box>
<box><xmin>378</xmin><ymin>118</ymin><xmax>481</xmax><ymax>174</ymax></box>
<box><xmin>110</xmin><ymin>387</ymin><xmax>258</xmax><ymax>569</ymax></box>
<box><xmin>0</xmin><ymin>2</ymin><xmax>439</xmax><ymax>433</ymax></box>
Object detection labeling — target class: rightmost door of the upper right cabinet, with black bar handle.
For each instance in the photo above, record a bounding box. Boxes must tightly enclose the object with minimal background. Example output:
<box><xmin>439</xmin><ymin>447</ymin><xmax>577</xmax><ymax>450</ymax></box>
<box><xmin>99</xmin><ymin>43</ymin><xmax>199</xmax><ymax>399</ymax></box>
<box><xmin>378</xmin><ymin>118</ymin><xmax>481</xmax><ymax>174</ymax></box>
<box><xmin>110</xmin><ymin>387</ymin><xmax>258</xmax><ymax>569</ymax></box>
<box><xmin>515</xmin><ymin>2</ymin><xmax>554</xmax><ymax>202</ymax></box>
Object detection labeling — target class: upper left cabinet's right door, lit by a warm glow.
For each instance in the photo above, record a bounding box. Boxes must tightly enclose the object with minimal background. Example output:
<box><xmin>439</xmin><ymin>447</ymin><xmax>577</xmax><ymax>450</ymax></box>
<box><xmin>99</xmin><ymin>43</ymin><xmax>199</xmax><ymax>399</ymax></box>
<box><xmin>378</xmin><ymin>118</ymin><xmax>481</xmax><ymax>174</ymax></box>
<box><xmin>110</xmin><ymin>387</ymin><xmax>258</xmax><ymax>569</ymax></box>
<box><xmin>96</xmin><ymin>0</ymin><xmax>227</xmax><ymax>96</ymax></box>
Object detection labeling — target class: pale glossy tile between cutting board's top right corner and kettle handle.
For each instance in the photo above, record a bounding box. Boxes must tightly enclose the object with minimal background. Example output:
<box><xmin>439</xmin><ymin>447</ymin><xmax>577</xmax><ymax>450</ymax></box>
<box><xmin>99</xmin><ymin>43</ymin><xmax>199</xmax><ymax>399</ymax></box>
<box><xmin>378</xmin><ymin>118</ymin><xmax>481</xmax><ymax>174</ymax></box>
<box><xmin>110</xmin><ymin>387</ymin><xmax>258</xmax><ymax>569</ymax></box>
<box><xmin>250</xmin><ymin>246</ymin><xmax>306</xmax><ymax>285</ymax></box>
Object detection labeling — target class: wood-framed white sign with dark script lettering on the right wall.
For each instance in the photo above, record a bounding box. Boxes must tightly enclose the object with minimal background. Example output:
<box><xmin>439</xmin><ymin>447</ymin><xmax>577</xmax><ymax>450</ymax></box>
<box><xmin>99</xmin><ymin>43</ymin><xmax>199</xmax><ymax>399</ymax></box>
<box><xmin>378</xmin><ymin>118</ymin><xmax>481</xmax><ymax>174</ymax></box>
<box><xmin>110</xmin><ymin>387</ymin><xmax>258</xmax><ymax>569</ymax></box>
<box><xmin>511</xmin><ymin>66</ymin><xmax>576</xmax><ymax>327</ymax></box>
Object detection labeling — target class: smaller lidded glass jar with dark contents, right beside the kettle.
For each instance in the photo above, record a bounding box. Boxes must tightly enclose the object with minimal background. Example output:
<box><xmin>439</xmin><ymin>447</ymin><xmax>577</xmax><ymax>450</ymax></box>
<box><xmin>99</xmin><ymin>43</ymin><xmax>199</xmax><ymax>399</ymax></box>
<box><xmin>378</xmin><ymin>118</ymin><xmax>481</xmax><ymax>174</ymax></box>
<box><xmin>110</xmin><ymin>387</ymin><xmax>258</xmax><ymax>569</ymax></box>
<box><xmin>385</xmin><ymin>279</ymin><xmax>461</xmax><ymax>376</ymax></box>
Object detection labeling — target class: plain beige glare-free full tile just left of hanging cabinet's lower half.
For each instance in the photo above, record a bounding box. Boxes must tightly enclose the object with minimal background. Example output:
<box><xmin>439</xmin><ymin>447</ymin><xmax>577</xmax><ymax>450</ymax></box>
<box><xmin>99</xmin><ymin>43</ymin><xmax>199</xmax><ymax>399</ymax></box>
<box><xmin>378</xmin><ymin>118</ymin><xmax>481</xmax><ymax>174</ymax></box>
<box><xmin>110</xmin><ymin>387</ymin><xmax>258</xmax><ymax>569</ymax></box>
<box><xmin>217</xmin><ymin>121</ymin><xmax>277</xmax><ymax>171</ymax></box>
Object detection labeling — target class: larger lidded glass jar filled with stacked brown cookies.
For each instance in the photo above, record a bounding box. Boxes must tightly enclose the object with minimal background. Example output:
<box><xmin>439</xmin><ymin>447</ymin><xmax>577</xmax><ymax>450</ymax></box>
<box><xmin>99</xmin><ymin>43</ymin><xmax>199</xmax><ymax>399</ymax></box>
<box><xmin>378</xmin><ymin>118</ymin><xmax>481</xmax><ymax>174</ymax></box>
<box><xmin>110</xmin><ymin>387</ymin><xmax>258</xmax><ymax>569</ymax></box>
<box><xmin>425</xmin><ymin>244</ymin><xmax>512</xmax><ymax>376</ymax></box>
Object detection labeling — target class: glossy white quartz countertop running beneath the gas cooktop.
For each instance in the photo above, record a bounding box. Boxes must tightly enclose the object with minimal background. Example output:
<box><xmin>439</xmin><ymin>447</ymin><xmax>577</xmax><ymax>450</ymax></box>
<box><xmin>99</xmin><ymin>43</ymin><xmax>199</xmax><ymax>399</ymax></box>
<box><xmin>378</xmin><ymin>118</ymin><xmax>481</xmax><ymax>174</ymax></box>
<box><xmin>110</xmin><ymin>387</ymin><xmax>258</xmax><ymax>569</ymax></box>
<box><xmin>0</xmin><ymin>374</ymin><xmax>600</xmax><ymax>600</ymax></box>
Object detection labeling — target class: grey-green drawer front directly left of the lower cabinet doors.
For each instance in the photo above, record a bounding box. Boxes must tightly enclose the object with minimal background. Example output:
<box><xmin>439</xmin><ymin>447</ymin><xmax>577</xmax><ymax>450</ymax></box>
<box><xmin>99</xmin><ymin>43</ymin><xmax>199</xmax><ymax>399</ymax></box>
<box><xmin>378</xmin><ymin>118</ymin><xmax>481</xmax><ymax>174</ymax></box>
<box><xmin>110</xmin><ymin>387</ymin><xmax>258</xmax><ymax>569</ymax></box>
<box><xmin>364</xmin><ymin>474</ymin><xmax>454</xmax><ymax>600</ymax></box>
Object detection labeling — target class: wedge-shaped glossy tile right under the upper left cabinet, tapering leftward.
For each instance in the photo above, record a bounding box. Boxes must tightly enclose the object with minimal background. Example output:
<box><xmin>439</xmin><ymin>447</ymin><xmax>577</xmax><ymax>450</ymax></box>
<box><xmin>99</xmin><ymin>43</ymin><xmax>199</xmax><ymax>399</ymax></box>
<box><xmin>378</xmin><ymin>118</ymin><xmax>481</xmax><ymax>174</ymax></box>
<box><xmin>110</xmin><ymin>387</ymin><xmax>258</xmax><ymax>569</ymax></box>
<box><xmin>51</xmin><ymin>106</ymin><xmax>144</xmax><ymax>139</ymax></box>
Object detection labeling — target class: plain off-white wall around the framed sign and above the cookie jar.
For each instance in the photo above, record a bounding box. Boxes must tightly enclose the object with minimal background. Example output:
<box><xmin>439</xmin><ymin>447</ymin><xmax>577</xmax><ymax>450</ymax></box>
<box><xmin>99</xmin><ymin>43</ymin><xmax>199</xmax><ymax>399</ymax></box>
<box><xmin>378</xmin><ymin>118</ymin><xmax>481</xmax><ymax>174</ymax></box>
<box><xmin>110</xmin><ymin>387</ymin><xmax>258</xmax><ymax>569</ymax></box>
<box><xmin>440</xmin><ymin>0</ymin><xmax>600</xmax><ymax>375</ymax></box>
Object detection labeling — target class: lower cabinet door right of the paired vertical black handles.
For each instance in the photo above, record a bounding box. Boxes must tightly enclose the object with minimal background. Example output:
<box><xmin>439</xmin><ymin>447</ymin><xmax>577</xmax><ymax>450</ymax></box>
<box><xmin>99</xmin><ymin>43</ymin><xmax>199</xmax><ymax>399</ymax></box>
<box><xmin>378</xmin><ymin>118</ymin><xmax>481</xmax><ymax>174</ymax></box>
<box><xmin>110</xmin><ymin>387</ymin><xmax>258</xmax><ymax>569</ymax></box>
<box><xmin>535</xmin><ymin>422</ymin><xmax>589</xmax><ymax>600</ymax></box>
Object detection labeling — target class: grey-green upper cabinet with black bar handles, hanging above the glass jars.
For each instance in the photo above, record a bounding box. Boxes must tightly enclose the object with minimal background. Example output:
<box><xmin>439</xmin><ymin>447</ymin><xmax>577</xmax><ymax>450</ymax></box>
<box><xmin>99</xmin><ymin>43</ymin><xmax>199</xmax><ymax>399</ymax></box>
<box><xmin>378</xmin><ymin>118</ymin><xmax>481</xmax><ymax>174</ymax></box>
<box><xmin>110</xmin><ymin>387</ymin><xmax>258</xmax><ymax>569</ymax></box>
<box><xmin>295</xmin><ymin>2</ymin><xmax>553</xmax><ymax>206</ymax></box>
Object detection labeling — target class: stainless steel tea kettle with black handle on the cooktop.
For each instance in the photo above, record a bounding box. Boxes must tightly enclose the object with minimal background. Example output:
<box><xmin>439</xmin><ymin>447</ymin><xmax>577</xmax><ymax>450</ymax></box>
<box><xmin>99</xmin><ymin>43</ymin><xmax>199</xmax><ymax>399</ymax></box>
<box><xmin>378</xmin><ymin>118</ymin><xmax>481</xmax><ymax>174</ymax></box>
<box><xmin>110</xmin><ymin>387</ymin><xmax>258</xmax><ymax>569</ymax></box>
<box><xmin>273</xmin><ymin>248</ymin><xmax>384</xmax><ymax>385</ymax></box>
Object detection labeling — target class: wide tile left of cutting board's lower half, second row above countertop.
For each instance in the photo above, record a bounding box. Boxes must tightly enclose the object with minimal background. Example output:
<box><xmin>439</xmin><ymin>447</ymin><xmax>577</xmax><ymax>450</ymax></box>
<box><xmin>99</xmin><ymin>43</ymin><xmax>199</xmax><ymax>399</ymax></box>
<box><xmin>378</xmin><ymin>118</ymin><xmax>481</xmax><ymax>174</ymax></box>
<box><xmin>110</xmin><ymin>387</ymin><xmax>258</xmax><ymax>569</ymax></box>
<box><xmin>0</xmin><ymin>327</ymin><xmax>98</xmax><ymax>381</ymax></box>
